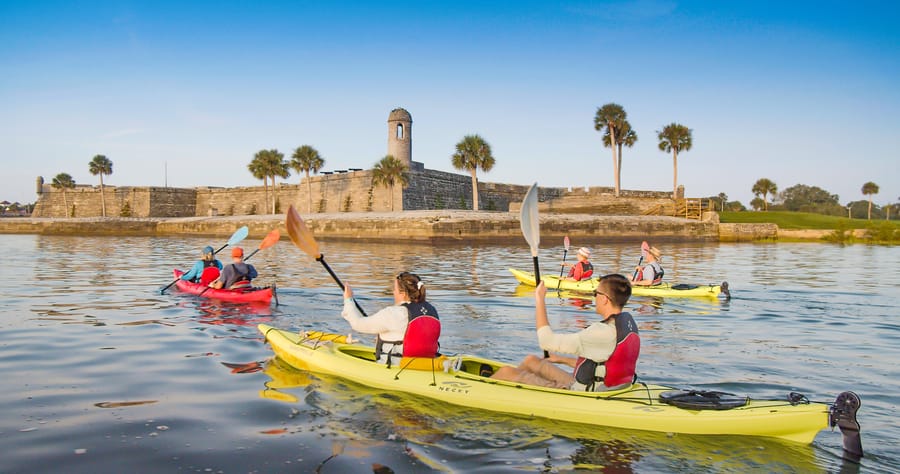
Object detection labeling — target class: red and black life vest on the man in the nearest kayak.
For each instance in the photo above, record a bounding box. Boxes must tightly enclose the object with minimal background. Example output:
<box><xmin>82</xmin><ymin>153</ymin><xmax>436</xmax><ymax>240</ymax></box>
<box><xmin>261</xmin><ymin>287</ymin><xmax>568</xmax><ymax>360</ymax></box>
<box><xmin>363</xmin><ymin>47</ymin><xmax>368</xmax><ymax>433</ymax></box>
<box><xmin>575</xmin><ymin>313</ymin><xmax>641</xmax><ymax>391</ymax></box>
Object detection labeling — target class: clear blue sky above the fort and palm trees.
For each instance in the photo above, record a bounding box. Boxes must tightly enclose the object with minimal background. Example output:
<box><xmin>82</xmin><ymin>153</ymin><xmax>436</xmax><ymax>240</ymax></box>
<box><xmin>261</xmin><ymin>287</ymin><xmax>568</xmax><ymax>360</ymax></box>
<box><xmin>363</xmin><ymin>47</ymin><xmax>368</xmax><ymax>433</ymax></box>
<box><xmin>0</xmin><ymin>0</ymin><xmax>900</xmax><ymax>205</ymax></box>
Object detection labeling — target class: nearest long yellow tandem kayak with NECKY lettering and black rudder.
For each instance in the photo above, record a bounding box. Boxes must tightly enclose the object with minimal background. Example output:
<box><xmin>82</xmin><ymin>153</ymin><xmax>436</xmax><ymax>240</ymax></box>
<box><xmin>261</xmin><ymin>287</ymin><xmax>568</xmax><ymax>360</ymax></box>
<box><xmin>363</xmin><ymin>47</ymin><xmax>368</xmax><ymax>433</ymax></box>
<box><xmin>258</xmin><ymin>324</ymin><xmax>861</xmax><ymax>449</ymax></box>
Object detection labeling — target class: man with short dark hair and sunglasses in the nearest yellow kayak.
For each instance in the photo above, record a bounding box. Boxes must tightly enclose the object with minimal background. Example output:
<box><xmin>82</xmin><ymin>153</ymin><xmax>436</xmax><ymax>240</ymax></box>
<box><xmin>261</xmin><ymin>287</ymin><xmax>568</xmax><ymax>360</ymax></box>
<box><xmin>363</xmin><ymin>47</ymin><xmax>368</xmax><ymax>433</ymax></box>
<box><xmin>491</xmin><ymin>274</ymin><xmax>640</xmax><ymax>391</ymax></box>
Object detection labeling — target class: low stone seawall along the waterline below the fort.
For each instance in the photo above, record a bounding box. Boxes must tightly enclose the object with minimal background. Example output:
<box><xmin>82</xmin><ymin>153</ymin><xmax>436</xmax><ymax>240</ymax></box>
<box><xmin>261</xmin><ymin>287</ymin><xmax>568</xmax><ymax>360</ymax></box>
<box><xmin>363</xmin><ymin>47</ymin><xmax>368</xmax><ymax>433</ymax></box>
<box><xmin>0</xmin><ymin>210</ymin><xmax>831</xmax><ymax>243</ymax></box>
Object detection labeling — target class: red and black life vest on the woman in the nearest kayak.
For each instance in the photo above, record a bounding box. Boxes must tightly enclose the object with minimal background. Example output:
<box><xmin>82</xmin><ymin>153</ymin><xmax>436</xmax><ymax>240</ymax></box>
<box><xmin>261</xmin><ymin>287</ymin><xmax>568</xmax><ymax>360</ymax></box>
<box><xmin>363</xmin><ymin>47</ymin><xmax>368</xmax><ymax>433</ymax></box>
<box><xmin>375</xmin><ymin>302</ymin><xmax>441</xmax><ymax>367</ymax></box>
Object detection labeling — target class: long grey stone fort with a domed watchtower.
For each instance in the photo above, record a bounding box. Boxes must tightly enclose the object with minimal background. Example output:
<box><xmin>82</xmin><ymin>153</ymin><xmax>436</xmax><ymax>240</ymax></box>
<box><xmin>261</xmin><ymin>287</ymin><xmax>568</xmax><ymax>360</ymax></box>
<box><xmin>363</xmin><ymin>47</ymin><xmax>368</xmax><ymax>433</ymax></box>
<box><xmin>32</xmin><ymin>108</ymin><xmax>674</xmax><ymax>218</ymax></box>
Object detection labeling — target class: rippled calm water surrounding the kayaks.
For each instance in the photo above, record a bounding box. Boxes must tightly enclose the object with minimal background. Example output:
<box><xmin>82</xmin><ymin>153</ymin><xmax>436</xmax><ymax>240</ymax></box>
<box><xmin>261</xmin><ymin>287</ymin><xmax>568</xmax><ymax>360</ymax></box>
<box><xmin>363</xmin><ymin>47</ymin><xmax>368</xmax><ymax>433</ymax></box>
<box><xmin>0</xmin><ymin>235</ymin><xmax>900</xmax><ymax>473</ymax></box>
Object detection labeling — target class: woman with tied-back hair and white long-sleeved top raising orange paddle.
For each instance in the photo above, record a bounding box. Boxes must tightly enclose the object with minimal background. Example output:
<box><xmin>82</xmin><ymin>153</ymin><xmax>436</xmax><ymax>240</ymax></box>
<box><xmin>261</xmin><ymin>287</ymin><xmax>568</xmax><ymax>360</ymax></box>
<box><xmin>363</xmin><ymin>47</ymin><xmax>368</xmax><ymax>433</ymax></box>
<box><xmin>341</xmin><ymin>272</ymin><xmax>441</xmax><ymax>366</ymax></box>
